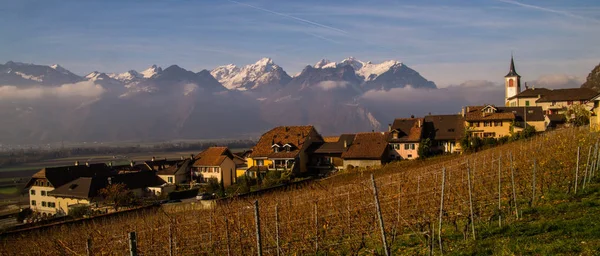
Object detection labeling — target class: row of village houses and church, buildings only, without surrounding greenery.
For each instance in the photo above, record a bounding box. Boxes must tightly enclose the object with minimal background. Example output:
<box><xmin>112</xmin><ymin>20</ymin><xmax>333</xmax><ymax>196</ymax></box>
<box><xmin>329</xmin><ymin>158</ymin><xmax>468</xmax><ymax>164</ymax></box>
<box><xmin>22</xmin><ymin>56</ymin><xmax>600</xmax><ymax>218</ymax></box>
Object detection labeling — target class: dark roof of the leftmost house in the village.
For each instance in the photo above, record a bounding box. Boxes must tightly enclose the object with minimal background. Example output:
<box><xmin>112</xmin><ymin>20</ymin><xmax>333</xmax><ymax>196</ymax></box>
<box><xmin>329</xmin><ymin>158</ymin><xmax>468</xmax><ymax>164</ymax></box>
<box><xmin>25</xmin><ymin>163</ymin><xmax>113</xmax><ymax>188</ymax></box>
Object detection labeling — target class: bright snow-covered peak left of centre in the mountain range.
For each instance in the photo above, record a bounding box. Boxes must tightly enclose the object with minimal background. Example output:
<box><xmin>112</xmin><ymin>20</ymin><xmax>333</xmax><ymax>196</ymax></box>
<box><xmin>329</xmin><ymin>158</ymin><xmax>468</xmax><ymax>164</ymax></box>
<box><xmin>210</xmin><ymin>58</ymin><xmax>291</xmax><ymax>91</ymax></box>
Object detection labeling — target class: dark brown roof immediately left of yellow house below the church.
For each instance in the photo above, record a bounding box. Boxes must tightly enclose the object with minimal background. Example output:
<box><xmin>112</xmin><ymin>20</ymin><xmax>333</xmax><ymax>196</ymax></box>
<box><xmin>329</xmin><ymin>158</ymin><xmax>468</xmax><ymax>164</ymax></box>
<box><xmin>424</xmin><ymin>115</ymin><xmax>465</xmax><ymax>140</ymax></box>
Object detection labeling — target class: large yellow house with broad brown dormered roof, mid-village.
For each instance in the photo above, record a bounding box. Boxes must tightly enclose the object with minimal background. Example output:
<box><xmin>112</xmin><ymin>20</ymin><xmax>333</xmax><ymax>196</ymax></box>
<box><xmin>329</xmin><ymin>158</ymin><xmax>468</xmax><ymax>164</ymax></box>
<box><xmin>247</xmin><ymin>126</ymin><xmax>323</xmax><ymax>173</ymax></box>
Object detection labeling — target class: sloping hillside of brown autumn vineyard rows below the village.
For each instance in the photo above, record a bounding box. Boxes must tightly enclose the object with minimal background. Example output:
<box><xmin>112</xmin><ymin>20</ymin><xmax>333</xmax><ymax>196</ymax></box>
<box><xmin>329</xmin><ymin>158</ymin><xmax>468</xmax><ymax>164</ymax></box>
<box><xmin>0</xmin><ymin>128</ymin><xmax>600</xmax><ymax>255</ymax></box>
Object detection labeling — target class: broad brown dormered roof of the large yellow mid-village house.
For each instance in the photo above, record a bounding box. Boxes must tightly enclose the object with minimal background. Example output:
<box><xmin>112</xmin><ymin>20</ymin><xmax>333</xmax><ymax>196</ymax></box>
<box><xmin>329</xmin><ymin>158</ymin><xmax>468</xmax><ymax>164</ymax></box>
<box><xmin>249</xmin><ymin>125</ymin><xmax>323</xmax><ymax>158</ymax></box>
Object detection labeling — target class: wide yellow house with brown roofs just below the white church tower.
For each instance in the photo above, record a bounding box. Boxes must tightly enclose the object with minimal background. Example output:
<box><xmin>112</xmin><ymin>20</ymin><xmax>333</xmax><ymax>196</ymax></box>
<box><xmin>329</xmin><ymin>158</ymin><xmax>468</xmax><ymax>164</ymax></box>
<box><xmin>463</xmin><ymin>105</ymin><xmax>549</xmax><ymax>138</ymax></box>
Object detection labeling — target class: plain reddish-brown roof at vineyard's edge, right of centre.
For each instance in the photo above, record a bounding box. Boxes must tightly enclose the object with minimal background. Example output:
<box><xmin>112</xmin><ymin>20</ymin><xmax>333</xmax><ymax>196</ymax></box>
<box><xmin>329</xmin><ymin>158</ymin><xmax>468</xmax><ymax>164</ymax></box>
<box><xmin>342</xmin><ymin>132</ymin><xmax>389</xmax><ymax>159</ymax></box>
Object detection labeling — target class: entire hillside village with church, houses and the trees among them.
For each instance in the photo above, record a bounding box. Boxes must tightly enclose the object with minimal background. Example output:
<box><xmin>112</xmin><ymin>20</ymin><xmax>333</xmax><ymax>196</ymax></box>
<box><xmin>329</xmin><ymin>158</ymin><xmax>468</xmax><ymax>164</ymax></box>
<box><xmin>16</xmin><ymin>58</ymin><xmax>600</xmax><ymax>226</ymax></box>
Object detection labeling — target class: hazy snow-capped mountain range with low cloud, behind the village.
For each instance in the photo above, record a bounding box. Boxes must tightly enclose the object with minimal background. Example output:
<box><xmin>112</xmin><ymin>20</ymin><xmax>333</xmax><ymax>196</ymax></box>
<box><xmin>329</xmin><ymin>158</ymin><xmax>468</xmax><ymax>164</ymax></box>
<box><xmin>0</xmin><ymin>57</ymin><xmax>436</xmax><ymax>144</ymax></box>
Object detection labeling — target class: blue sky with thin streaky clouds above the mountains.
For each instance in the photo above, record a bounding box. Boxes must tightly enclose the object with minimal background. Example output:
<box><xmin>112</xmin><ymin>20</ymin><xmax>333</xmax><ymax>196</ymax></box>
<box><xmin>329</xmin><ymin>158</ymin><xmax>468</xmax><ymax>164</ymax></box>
<box><xmin>0</xmin><ymin>0</ymin><xmax>600</xmax><ymax>86</ymax></box>
